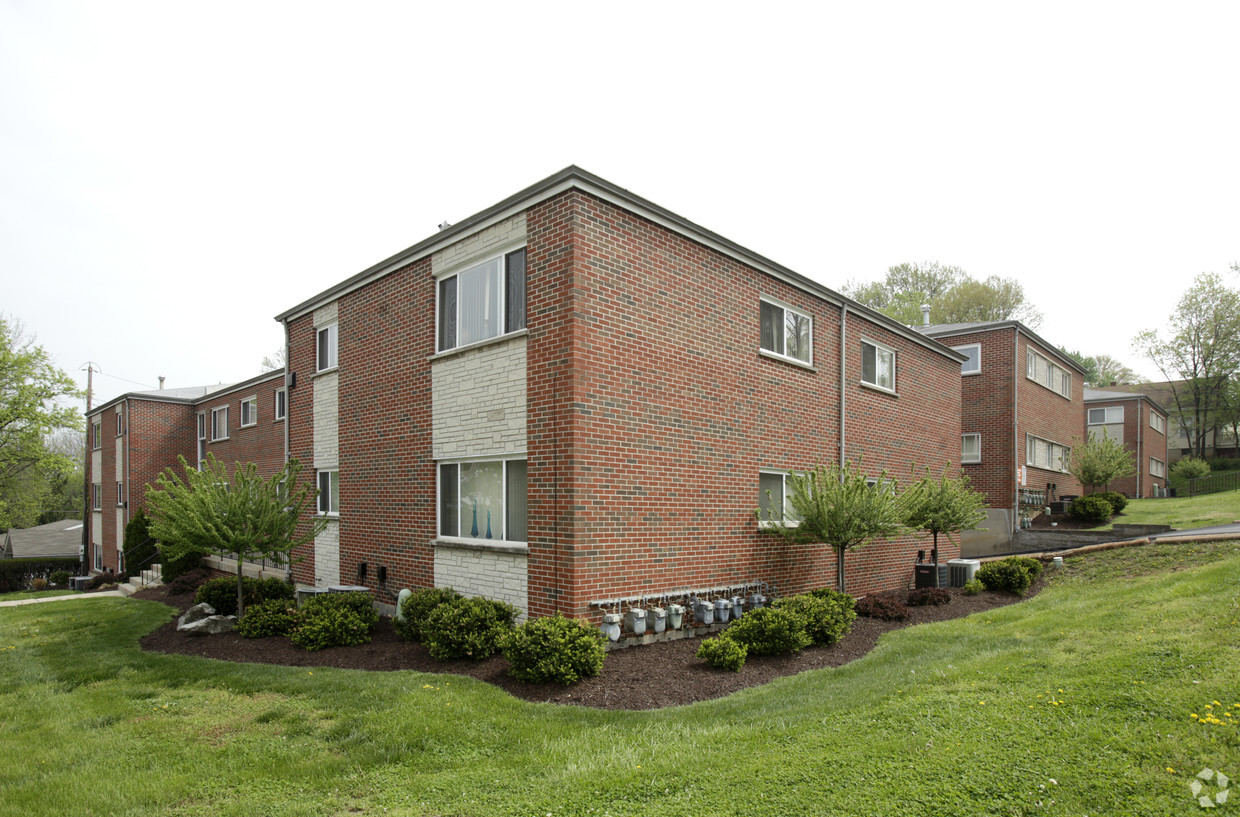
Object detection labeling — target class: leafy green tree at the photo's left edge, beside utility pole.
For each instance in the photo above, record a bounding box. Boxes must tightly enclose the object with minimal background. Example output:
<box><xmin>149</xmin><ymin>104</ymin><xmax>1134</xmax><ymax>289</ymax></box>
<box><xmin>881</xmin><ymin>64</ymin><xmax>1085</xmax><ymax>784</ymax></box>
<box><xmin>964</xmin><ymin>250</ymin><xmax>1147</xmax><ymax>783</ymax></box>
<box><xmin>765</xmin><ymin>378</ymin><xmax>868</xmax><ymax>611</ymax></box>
<box><xmin>0</xmin><ymin>316</ymin><xmax>84</xmax><ymax>528</ymax></box>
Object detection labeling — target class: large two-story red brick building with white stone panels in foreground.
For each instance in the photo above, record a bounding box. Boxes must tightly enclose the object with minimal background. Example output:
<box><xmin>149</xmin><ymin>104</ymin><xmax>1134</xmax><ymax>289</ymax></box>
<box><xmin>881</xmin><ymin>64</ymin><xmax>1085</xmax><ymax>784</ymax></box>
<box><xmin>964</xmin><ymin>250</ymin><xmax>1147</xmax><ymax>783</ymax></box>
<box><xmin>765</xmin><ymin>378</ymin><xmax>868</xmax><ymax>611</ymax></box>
<box><xmin>84</xmin><ymin>167</ymin><xmax>967</xmax><ymax>616</ymax></box>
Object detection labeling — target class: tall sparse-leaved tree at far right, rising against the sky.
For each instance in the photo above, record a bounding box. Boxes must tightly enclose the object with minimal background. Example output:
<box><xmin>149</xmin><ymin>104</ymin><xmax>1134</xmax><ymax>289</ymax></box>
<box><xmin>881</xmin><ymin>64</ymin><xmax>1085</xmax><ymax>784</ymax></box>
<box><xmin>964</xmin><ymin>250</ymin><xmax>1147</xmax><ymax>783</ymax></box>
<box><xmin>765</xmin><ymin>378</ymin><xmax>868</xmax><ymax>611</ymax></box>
<box><xmin>1132</xmin><ymin>273</ymin><xmax>1240</xmax><ymax>457</ymax></box>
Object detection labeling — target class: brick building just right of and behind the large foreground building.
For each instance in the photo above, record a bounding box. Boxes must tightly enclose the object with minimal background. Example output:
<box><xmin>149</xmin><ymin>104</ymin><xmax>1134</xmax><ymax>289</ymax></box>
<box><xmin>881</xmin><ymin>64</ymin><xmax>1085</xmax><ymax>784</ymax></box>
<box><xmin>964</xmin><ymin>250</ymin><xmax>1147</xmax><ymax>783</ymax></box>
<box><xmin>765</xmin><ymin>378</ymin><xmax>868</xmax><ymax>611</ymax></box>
<box><xmin>918</xmin><ymin>321</ymin><xmax>1085</xmax><ymax>555</ymax></box>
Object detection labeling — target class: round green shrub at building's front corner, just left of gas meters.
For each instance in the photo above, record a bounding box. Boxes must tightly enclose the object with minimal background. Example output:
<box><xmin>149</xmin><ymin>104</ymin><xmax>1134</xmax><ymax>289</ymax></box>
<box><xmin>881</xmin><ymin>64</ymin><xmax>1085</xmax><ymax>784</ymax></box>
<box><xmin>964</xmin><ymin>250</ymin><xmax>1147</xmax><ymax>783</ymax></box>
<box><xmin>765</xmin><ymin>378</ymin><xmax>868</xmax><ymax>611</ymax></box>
<box><xmin>500</xmin><ymin>612</ymin><xmax>608</xmax><ymax>687</ymax></box>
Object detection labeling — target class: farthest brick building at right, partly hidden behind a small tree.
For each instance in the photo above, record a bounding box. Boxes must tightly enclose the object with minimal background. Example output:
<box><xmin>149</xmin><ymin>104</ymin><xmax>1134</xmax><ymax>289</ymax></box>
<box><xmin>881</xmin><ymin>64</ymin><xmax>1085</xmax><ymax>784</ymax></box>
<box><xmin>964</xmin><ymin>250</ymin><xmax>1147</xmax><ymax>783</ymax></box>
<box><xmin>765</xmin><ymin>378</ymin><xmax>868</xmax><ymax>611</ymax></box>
<box><xmin>1085</xmin><ymin>388</ymin><xmax>1167</xmax><ymax>498</ymax></box>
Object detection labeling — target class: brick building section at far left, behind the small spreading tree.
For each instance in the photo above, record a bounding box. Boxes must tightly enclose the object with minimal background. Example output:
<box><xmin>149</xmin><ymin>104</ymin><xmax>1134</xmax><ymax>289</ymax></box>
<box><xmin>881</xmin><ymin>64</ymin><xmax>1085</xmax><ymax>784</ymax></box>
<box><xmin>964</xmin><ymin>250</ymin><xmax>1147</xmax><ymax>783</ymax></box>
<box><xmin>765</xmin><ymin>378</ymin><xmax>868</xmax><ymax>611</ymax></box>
<box><xmin>87</xmin><ymin>372</ymin><xmax>284</xmax><ymax>573</ymax></box>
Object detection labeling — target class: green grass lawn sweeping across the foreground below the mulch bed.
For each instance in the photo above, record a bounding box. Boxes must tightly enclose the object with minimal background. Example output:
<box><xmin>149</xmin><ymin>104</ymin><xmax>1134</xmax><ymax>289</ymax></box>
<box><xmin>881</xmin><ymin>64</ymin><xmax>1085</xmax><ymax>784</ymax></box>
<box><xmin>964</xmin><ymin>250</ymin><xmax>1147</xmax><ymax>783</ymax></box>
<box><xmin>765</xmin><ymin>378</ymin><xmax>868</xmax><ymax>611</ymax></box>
<box><xmin>0</xmin><ymin>542</ymin><xmax>1240</xmax><ymax>817</ymax></box>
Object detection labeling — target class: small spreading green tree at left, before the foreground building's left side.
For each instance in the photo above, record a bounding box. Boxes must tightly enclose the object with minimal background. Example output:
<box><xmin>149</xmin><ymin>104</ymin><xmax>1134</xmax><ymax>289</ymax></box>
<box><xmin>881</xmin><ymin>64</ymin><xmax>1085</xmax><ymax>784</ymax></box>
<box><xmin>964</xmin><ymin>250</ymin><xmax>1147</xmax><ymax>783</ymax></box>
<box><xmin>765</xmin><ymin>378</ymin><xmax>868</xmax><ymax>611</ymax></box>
<box><xmin>146</xmin><ymin>454</ymin><xmax>327</xmax><ymax>616</ymax></box>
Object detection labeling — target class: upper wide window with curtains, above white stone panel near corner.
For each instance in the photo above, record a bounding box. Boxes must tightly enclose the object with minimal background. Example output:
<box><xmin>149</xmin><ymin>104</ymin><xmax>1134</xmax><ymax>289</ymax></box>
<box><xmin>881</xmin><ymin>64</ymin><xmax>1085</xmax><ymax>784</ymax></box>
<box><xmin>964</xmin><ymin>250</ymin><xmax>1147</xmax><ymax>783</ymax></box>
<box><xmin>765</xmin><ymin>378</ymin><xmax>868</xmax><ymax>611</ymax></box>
<box><xmin>439</xmin><ymin>249</ymin><xmax>526</xmax><ymax>352</ymax></box>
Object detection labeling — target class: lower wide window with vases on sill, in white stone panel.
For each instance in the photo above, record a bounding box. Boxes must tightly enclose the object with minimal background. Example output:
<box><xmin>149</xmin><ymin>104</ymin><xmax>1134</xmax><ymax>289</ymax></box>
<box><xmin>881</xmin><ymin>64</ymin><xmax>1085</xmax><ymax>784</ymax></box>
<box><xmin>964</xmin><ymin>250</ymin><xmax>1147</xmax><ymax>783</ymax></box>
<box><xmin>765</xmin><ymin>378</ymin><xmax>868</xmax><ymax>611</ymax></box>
<box><xmin>439</xmin><ymin>460</ymin><xmax>527</xmax><ymax>542</ymax></box>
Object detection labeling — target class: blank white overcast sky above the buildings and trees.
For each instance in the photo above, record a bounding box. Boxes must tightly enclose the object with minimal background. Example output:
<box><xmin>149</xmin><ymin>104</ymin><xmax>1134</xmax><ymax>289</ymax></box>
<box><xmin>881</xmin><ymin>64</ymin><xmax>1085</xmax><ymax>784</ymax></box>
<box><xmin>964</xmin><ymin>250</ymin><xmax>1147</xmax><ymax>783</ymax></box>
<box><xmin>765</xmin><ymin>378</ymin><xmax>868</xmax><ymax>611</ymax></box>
<box><xmin>0</xmin><ymin>0</ymin><xmax>1240</xmax><ymax>403</ymax></box>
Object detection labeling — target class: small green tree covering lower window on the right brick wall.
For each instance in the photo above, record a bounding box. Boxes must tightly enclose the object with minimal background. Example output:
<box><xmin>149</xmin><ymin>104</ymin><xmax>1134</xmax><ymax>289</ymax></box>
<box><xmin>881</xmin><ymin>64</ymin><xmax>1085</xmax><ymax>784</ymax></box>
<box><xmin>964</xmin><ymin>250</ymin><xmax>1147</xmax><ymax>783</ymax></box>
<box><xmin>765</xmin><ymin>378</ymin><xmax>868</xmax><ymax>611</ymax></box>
<box><xmin>764</xmin><ymin>460</ymin><xmax>904</xmax><ymax>593</ymax></box>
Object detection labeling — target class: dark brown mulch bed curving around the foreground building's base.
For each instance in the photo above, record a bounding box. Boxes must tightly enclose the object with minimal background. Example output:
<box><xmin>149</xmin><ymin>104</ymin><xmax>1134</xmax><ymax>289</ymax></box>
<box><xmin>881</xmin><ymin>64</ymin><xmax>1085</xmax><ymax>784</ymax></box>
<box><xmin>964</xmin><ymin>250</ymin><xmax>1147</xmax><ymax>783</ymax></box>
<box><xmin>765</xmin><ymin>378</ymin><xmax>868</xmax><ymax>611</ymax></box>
<box><xmin>134</xmin><ymin>579</ymin><xmax>1043</xmax><ymax>709</ymax></box>
